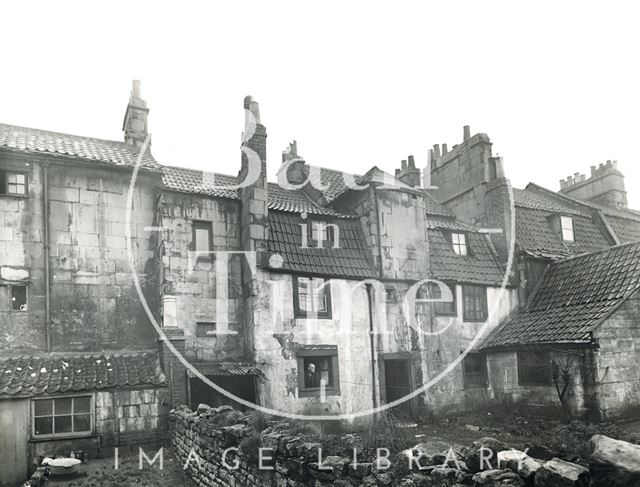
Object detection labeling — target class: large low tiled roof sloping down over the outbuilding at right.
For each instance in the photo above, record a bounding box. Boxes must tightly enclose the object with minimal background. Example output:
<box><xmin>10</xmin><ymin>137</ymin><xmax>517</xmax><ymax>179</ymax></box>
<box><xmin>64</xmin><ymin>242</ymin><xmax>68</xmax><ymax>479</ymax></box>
<box><xmin>483</xmin><ymin>242</ymin><xmax>640</xmax><ymax>348</ymax></box>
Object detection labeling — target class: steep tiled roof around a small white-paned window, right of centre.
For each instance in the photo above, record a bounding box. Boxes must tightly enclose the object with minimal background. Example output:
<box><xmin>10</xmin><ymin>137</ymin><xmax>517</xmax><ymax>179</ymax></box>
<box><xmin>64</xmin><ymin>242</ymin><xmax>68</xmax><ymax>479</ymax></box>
<box><xmin>428</xmin><ymin>222</ymin><xmax>505</xmax><ymax>286</ymax></box>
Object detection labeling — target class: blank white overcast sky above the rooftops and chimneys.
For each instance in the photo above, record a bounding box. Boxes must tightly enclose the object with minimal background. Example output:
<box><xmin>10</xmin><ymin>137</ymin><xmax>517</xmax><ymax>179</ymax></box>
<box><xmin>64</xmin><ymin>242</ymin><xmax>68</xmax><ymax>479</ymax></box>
<box><xmin>0</xmin><ymin>1</ymin><xmax>640</xmax><ymax>208</ymax></box>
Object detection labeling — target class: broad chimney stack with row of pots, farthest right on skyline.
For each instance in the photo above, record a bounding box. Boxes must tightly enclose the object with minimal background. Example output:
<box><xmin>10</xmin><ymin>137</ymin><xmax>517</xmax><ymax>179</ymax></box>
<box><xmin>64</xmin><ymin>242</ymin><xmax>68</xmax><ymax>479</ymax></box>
<box><xmin>560</xmin><ymin>160</ymin><xmax>627</xmax><ymax>208</ymax></box>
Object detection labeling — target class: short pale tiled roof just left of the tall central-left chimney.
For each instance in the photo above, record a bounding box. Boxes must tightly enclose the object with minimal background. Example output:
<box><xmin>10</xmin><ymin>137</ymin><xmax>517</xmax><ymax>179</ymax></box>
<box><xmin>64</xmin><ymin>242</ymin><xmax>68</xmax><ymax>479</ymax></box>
<box><xmin>162</xmin><ymin>166</ymin><xmax>238</xmax><ymax>199</ymax></box>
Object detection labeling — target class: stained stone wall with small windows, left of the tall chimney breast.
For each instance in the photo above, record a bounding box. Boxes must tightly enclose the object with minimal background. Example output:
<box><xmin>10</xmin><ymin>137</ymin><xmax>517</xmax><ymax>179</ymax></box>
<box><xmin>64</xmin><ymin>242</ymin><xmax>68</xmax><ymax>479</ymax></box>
<box><xmin>158</xmin><ymin>192</ymin><xmax>244</xmax><ymax>360</ymax></box>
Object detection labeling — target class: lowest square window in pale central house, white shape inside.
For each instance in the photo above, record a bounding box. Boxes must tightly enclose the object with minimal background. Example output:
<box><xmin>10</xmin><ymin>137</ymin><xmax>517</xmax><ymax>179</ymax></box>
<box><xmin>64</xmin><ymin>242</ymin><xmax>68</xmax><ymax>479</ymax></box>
<box><xmin>296</xmin><ymin>345</ymin><xmax>340</xmax><ymax>397</ymax></box>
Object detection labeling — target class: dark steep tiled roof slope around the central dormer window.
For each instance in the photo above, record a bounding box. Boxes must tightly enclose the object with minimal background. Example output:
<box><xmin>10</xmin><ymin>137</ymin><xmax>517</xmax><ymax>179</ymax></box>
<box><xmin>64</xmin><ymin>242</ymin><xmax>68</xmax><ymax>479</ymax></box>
<box><xmin>268</xmin><ymin>211</ymin><xmax>376</xmax><ymax>279</ymax></box>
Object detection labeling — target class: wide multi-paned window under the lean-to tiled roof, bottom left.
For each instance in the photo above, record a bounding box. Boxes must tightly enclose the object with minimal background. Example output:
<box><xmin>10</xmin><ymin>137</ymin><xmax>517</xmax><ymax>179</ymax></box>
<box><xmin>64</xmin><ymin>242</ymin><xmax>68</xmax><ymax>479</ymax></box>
<box><xmin>33</xmin><ymin>396</ymin><xmax>93</xmax><ymax>436</ymax></box>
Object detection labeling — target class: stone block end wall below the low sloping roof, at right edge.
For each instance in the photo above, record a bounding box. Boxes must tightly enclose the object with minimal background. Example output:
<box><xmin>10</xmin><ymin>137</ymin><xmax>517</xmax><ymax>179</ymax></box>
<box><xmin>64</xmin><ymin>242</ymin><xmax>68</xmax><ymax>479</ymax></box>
<box><xmin>594</xmin><ymin>291</ymin><xmax>640</xmax><ymax>419</ymax></box>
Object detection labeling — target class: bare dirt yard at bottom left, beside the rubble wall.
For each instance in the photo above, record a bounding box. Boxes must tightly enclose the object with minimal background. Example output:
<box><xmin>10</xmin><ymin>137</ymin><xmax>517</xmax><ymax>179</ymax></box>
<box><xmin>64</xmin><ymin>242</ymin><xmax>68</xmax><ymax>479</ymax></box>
<box><xmin>46</xmin><ymin>448</ymin><xmax>195</xmax><ymax>487</ymax></box>
